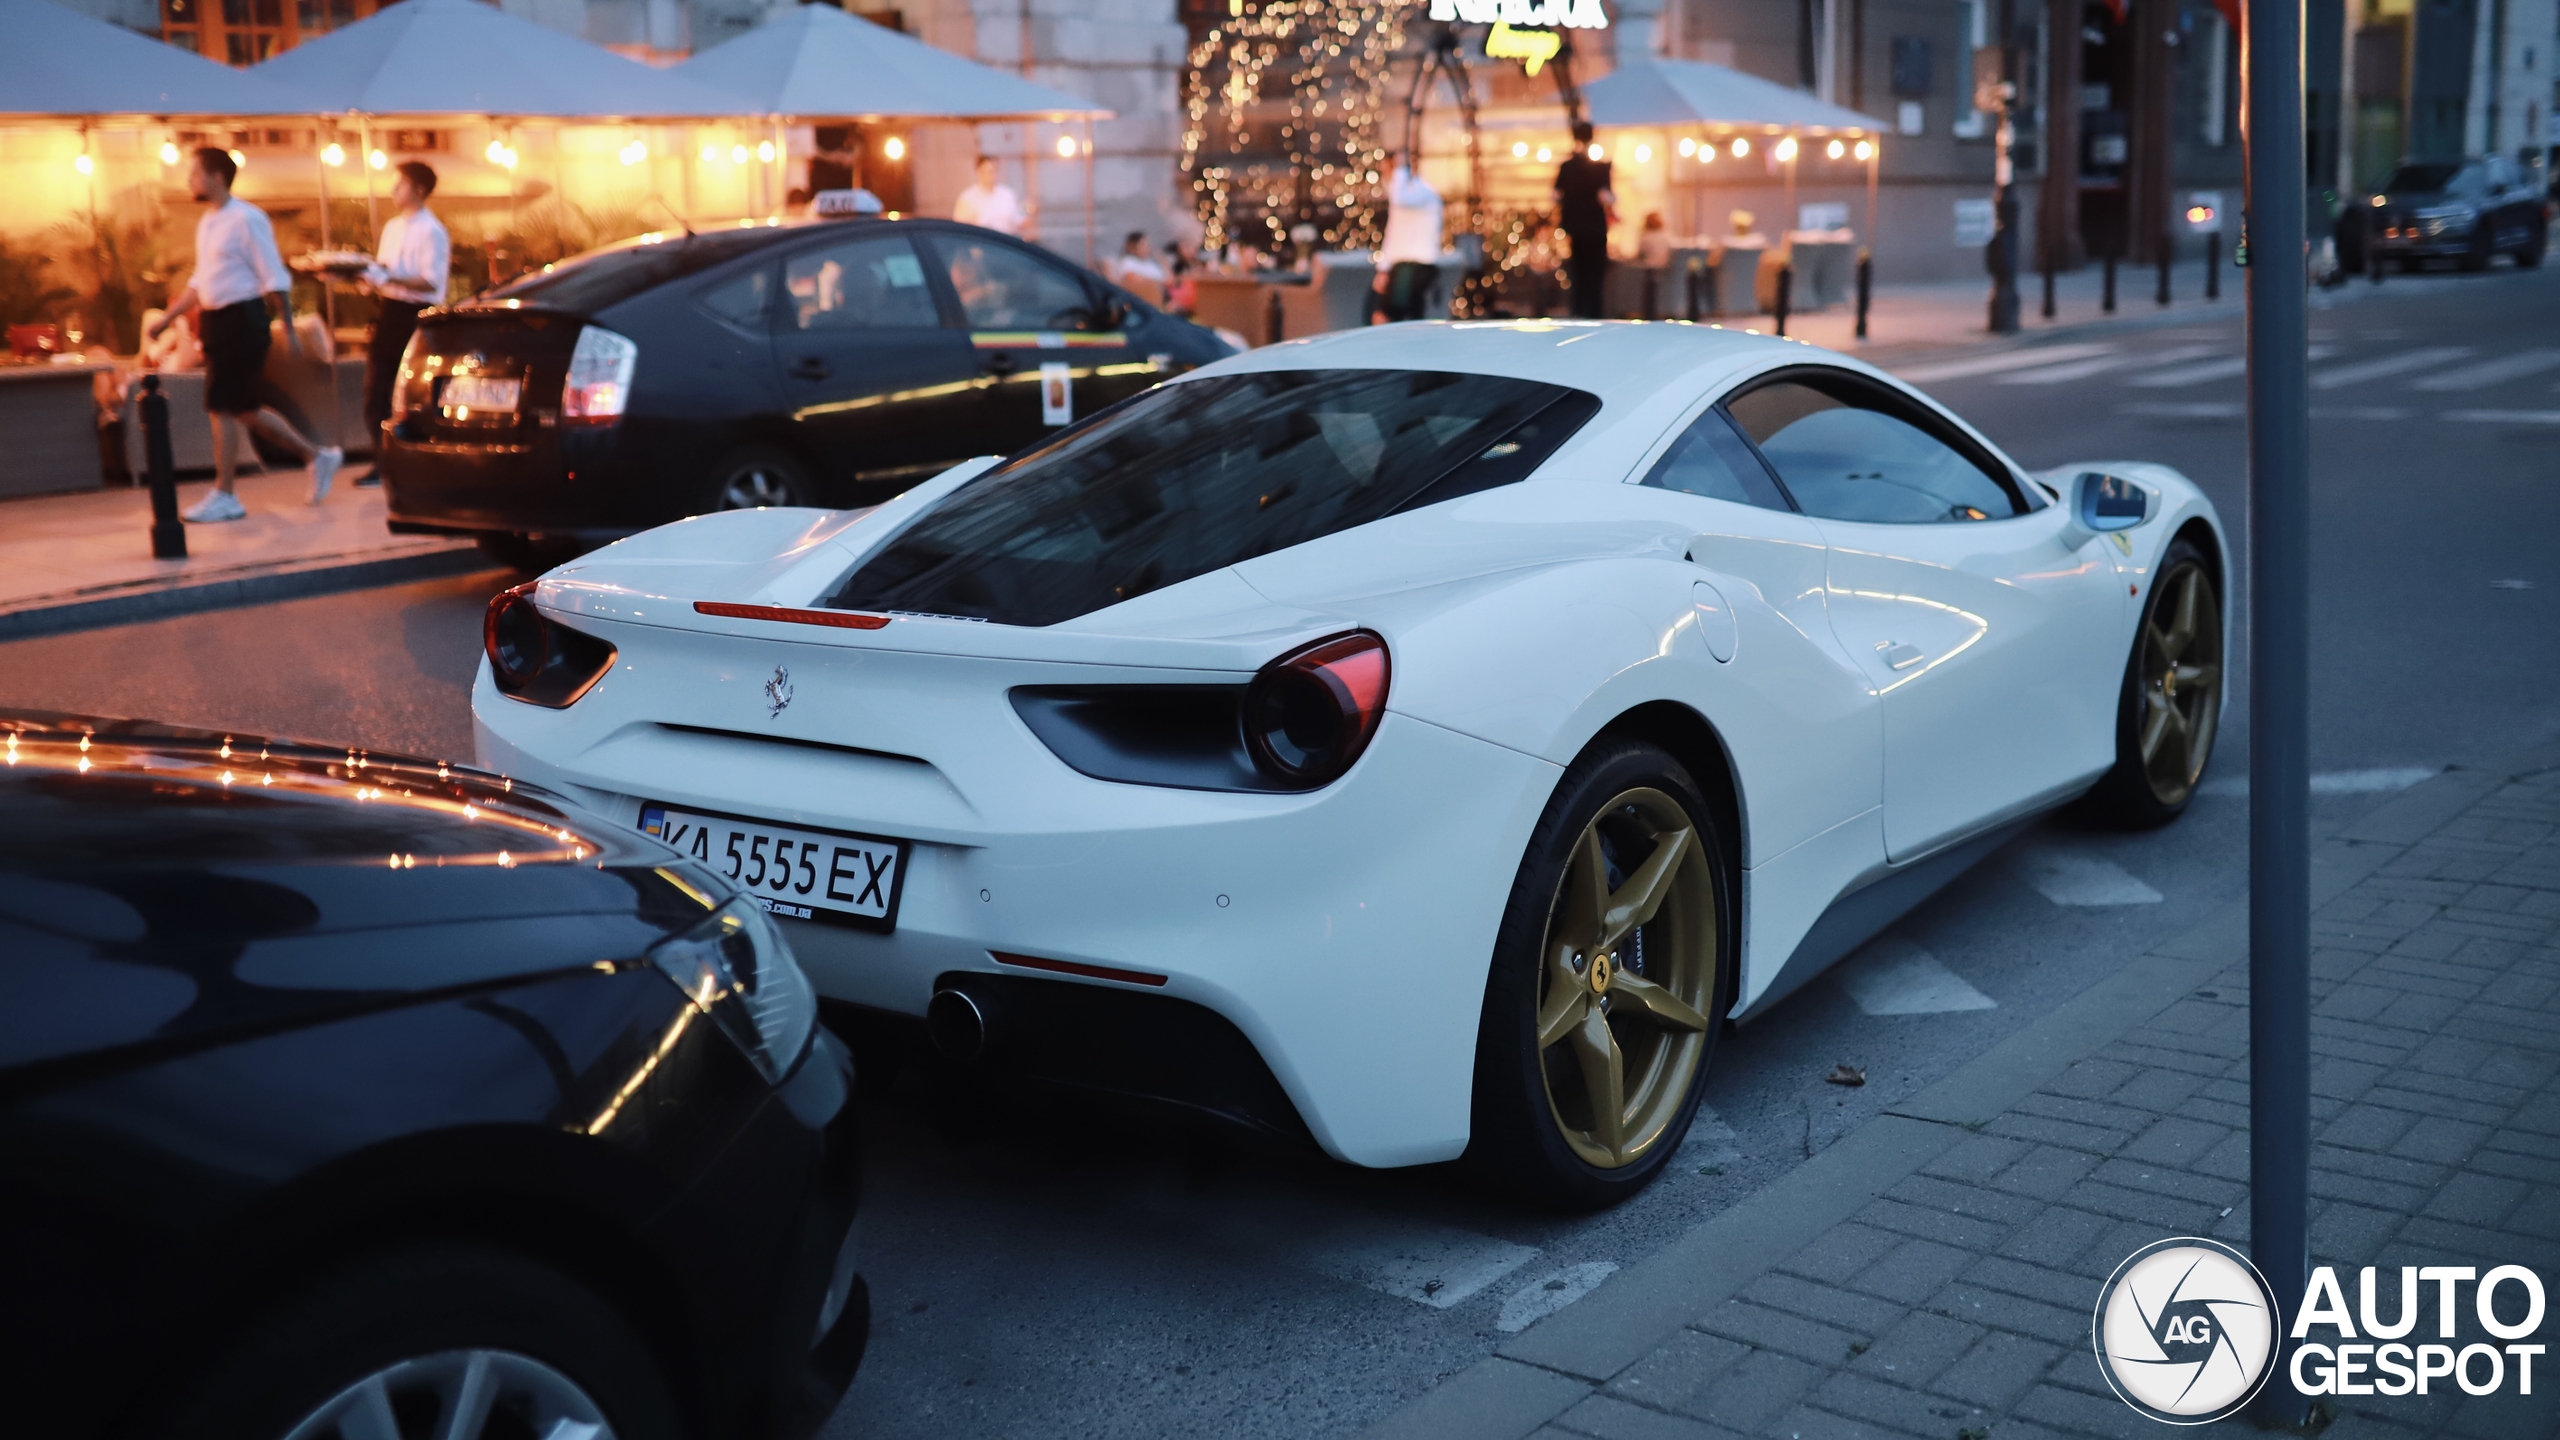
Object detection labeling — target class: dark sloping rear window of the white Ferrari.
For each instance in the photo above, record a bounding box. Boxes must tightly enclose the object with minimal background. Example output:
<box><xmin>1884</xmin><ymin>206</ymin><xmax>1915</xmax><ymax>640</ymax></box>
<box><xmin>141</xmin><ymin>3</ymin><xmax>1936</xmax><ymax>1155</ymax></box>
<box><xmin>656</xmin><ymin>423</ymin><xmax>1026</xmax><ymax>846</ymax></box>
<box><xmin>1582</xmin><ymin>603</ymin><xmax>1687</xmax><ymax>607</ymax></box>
<box><xmin>832</xmin><ymin>369</ymin><xmax>1600</xmax><ymax>625</ymax></box>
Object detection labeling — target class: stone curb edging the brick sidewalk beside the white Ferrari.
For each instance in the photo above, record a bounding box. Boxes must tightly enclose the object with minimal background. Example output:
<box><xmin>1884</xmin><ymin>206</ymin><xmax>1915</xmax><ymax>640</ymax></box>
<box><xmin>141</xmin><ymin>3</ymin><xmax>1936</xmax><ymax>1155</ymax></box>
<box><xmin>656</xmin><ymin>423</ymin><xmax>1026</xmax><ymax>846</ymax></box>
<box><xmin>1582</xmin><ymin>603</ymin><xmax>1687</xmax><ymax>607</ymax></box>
<box><xmin>1362</xmin><ymin>738</ymin><xmax>2560</xmax><ymax>1440</ymax></box>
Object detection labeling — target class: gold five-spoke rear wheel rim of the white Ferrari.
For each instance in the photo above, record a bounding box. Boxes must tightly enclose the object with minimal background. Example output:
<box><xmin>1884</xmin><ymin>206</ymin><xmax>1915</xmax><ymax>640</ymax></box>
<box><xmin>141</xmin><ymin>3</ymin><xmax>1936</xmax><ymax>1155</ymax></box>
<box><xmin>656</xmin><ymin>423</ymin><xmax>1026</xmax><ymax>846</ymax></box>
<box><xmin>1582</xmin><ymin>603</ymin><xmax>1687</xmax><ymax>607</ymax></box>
<box><xmin>1539</xmin><ymin>789</ymin><xmax>1718</xmax><ymax>1168</ymax></box>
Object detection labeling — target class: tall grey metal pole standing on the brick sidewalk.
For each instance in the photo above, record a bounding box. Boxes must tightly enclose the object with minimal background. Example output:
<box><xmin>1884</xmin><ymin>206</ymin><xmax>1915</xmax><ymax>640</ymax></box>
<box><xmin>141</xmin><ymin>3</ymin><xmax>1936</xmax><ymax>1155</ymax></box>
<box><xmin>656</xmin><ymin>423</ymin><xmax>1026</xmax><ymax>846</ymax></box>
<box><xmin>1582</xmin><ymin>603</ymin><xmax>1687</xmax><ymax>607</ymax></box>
<box><xmin>2240</xmin><ymin>0</ymin><xmax>2312</xmax><ymax>1425</ymax></box>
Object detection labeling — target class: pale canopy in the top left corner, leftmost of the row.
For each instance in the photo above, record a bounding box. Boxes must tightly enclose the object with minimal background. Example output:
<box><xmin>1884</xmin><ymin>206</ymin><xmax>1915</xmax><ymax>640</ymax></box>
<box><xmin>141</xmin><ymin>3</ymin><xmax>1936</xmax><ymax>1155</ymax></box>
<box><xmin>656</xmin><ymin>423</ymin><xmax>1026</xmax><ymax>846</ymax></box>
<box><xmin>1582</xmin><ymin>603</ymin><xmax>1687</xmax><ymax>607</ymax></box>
<box><xmin>0</xmin><ymin>0</ymin><xmax>310</xmax><ymax>118</ymax></box>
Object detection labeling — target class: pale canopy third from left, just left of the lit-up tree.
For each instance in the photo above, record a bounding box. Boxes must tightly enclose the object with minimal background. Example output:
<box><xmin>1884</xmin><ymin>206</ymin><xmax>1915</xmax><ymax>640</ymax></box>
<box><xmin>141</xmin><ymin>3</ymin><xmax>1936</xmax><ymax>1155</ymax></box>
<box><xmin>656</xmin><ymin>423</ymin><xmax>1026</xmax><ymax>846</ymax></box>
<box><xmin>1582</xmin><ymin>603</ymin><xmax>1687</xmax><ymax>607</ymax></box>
<box><xmin>680</xmin><ymin>0</ymin><xmax>1108</xmax><ymax>120</ymax></box>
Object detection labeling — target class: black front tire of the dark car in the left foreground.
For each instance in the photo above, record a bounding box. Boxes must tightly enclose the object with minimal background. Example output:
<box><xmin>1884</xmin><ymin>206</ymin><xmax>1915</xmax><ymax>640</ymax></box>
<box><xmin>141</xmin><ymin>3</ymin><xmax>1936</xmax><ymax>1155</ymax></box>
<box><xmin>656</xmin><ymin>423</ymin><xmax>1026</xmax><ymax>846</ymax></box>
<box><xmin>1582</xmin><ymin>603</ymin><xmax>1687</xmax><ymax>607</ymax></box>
<box><xmin>154</xmin><ymin>1243</ymin><xmax>686</xmax><ymax>1440</ymax></box>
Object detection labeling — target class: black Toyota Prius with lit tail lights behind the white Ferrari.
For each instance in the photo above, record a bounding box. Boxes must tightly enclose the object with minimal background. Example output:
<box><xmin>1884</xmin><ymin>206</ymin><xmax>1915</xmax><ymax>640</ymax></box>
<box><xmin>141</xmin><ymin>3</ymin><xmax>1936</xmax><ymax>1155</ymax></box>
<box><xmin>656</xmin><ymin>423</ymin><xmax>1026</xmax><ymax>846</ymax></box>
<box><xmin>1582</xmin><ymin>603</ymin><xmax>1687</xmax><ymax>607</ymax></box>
<box><xmin>379</xmin><ymin>220</ymin><xmax>1231</xmax><ymax>564</ymax></box>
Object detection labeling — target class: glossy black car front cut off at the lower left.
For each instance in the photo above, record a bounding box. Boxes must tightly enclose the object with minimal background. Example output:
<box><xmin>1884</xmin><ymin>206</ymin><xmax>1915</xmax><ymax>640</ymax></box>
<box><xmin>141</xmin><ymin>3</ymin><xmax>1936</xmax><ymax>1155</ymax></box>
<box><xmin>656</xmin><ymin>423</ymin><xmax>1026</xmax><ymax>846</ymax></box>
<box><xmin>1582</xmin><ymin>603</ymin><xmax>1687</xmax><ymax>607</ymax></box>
<box><xmin>0</xmin><ymin>712</ymin><xmax>870</xmax><ymax>1440</ymax></box>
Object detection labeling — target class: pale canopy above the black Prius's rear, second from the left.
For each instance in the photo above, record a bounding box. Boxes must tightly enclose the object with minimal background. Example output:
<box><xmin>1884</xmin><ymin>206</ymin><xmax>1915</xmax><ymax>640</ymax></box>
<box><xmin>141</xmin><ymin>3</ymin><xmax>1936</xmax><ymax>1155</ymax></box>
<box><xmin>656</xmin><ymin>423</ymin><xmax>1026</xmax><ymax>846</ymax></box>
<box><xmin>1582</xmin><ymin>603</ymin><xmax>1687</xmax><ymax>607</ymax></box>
<box><xmin>248</xmin><ymin>0</ymin><xmax>750</xmax><ymax>120</ymax></box>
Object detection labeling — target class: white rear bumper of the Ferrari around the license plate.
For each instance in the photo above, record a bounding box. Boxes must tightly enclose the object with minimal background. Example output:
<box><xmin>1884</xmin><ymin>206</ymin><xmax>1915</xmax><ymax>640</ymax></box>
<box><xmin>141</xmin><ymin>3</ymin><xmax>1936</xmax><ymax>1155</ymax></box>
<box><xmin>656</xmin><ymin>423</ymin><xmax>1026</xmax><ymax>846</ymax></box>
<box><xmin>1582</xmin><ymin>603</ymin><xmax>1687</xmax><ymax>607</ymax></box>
<box><xmin>474</xmin><ymin>651</ymin><xmax>1559</xmax><ymax>1166</ymax></box>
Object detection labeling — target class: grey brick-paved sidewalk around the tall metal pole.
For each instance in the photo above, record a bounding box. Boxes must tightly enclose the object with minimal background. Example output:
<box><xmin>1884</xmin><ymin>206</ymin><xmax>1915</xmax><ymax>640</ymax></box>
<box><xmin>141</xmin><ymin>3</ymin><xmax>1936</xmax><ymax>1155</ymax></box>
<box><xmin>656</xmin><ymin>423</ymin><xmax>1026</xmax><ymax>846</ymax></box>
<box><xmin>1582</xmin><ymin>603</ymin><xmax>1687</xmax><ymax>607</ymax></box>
<box><xmin>1375</xmin><ymin>746</ymin><xmax>2560</xmax><ymax>1440</ymax></box>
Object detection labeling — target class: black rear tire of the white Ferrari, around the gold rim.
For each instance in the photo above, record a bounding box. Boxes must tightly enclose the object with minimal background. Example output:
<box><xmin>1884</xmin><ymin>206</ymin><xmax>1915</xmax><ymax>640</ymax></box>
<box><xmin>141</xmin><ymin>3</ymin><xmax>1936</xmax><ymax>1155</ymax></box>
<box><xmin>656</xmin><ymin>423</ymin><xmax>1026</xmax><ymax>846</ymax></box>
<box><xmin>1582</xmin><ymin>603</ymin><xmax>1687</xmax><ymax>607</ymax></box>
<box><xmin>1467</xmin><ymin>738</ymin><xmax>1736</xmax><ymax>1209</ymax></box>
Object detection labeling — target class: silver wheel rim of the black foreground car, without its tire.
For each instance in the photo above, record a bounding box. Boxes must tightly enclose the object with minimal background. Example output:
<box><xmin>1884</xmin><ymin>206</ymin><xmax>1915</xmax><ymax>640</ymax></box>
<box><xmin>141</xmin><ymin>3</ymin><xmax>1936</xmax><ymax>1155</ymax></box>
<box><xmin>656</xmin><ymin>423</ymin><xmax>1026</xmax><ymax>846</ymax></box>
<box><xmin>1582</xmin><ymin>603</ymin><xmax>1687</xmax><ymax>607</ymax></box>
<box><xmin>284</xmin><ymin>1350</ymin><xmax>614</xmax><ymax>1440</ymax></box>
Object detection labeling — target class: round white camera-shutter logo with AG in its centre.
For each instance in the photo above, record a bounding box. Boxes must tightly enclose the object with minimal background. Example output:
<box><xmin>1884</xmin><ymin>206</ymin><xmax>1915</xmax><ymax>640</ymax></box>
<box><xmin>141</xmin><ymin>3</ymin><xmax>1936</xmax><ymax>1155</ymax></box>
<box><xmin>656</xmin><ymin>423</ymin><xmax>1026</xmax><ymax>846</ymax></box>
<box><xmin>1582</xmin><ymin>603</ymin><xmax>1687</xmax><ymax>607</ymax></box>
<box><xmin>2092</xmin><ymin>1238</ymin><xmax>2276</xmax><ymax>1425</ymax></box>
